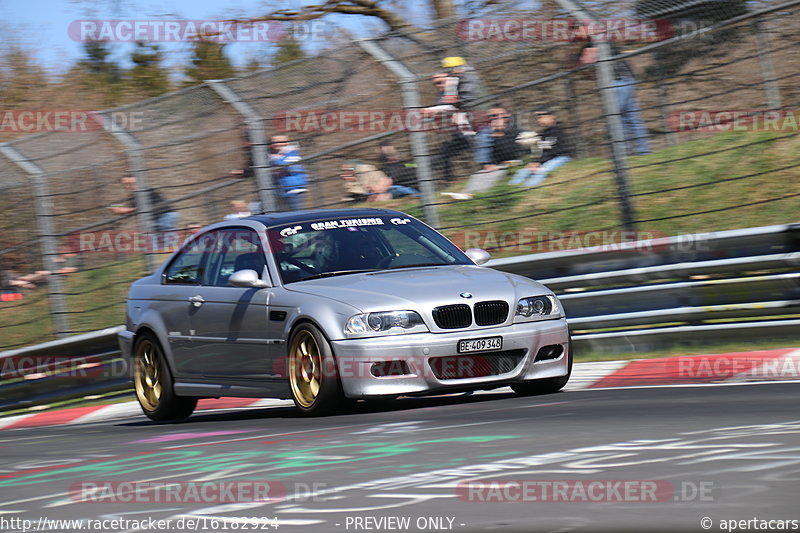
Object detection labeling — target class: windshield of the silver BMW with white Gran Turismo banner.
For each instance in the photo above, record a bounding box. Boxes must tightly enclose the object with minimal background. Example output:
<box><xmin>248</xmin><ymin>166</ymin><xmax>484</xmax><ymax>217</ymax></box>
<box><xmin>268</xmin><ymin>216</ymin><xmax>472</xmax><ymax>283</ymax></box>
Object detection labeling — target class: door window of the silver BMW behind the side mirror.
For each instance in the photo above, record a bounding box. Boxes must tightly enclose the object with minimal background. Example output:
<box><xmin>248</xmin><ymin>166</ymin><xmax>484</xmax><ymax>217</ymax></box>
<box><xmin>203</xmin><ymin>228</ymin><xmax>266</xmax><ymax>287</ymax></box>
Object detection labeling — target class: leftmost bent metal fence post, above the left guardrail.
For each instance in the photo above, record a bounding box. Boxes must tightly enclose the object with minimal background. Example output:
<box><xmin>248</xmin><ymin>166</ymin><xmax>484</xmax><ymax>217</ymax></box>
<box><xmin>0</xmin><ymin>144</ymin><xmax>69</xmax><ymax>339</ymax></box>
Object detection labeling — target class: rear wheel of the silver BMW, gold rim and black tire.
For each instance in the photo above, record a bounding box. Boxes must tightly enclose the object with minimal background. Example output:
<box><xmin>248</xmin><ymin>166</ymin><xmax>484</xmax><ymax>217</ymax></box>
<box><xmin>133</xmin><ymin>331</ymin><xmax>197</xmax><ymax>421</ymax></box>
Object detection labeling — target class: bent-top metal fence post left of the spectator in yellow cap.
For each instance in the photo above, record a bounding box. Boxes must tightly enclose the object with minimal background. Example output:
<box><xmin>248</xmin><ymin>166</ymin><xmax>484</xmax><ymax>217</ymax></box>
<box><xmin>357</xmin><ymin>39</ymin><xmax>441</xmax><ymax>228</ymax></box>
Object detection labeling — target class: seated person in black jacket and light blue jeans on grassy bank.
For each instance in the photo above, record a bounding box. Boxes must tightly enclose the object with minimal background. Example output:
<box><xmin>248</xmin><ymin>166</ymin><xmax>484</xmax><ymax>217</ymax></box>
<box><xmin>509</xmin><ymin>107</ymin><xmax>572</xmax><ymax>187</ymax></box>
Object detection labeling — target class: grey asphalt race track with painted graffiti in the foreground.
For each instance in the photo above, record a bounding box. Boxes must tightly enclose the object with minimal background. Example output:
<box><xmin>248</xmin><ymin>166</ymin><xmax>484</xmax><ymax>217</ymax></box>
<box><xmin>0</xmin><ymin>383</ymin><xmax>800</xmax><ymax>533</ymax></box>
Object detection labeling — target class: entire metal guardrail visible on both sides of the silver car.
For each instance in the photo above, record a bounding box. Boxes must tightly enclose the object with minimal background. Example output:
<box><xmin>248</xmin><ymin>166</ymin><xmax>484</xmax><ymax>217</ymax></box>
<box><xmin>0</xmin><ymin>224</ymin><xmax>800</xmax><ymax>411</ymax></box>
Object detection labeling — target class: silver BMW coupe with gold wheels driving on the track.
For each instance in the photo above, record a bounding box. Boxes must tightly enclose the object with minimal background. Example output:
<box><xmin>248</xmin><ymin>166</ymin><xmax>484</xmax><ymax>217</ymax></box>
<box><xmin>119</xmin><ymin>209</ymin><xmax>572</xmax><ymax>420</ymax></box>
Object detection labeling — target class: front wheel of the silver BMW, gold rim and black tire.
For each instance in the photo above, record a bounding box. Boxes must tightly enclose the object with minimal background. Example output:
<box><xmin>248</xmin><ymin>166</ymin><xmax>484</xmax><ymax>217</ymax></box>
<box><xmin>287</xmin><ymin>323</ymin><xmax>350</xmax><ymax>416</ymax></box>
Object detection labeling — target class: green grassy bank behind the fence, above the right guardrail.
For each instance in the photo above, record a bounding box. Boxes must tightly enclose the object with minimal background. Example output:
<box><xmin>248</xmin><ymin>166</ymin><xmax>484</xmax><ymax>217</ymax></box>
<box><xmin>382</xmin><ymin>132</ymin><xmax>800</xmax><ymax>257</ymax></box>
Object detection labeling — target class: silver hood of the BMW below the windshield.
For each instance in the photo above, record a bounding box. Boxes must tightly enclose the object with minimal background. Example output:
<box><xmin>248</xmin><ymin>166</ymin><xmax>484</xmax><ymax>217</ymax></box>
<box><xmin>286</xmin><ymin>265</ymin><xmax>550</xmax><ymax>312</ymax></box>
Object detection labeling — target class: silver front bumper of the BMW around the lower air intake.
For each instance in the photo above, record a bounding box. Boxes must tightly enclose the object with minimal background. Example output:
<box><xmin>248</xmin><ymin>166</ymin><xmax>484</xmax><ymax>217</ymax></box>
<box><xmin>332</xmin><ymin>318</ymin><xmax>569</xmax><ymax>398</ymax></box>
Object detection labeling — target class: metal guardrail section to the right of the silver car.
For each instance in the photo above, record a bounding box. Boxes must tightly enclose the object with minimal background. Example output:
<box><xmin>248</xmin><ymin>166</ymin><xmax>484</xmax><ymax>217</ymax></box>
<box><xmin>487</xmin><ymin>224</ymin><xmax>800</xmax><ymax>353</ymax></box>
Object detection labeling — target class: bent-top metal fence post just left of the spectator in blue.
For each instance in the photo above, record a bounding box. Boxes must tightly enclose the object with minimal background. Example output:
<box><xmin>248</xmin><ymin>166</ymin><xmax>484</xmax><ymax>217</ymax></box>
<box><xmin>206</xmin><ymin>80</ymin><xmax>278</xmax><ymax>212</ymax></box>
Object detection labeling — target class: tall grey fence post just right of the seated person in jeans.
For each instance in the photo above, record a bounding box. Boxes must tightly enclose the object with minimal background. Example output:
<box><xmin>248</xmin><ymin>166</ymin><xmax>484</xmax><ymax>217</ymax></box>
<box><xmin>557</xmin><ymin>0</ymin><xmax>635</xmax><ymax>230</ymax></box>
